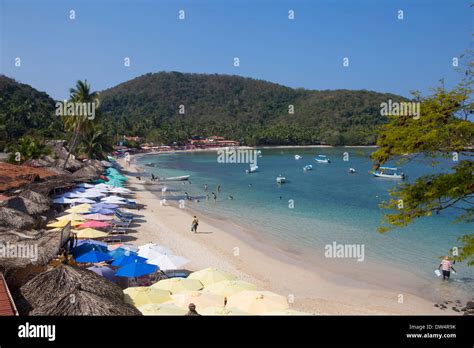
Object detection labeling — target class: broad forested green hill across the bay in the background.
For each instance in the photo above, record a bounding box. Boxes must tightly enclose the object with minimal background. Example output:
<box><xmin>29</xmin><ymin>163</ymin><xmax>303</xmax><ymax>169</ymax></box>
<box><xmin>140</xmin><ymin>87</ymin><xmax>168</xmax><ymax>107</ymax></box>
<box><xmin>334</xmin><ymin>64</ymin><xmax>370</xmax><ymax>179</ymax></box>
<box><xmin>100</xmin><ymin>72</ymin><xmax>404</xmax><ymax>145</ymax></box>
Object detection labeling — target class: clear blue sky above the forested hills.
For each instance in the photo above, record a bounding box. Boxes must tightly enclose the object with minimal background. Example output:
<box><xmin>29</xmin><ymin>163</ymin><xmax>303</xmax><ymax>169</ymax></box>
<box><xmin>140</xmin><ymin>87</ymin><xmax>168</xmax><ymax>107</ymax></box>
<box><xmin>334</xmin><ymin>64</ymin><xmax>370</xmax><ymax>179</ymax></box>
<box><xmin>0</xmin><ymin>0</ymin><xmax>473</xmax><ymax>99</ymax></box>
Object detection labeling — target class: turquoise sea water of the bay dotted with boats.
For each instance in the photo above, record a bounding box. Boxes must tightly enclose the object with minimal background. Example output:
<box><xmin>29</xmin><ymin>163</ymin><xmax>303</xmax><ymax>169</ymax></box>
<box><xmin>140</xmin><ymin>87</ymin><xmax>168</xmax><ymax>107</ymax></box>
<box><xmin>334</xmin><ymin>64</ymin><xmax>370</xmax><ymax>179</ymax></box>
<box><xmin>137</xmin><ymin>148</ymin><xmax>474</xmax><ymax>295</ymax></box>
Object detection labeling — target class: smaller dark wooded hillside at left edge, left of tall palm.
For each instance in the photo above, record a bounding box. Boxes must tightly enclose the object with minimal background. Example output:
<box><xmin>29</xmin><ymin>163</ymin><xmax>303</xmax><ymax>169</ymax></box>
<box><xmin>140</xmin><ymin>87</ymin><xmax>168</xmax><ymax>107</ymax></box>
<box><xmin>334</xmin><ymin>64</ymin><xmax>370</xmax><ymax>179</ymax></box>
<box><xmin>0</xmin><ymin>75</ymin><xmax>62</xmax><ymax>150</ymax></box>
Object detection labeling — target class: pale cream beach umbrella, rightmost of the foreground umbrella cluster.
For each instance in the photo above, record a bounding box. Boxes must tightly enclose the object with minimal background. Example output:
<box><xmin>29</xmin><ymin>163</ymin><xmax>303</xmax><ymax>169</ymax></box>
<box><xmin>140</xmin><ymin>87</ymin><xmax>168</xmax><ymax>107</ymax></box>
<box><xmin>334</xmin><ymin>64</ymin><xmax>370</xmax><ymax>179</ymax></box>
<box><xmin>226</xmin><ymin>290</ymin><xmax>289</xmax><ymax>314</ymax></box>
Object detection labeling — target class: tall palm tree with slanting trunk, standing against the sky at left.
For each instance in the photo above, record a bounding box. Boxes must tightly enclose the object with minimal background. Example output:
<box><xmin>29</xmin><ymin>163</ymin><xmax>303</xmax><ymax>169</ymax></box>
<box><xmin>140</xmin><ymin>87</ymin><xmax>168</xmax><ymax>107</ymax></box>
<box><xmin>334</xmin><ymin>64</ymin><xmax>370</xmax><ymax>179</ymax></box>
<box><xmin>63</xmin><ymin>80</ymin><xmax>98</xmax><ymax>169</ymax></box>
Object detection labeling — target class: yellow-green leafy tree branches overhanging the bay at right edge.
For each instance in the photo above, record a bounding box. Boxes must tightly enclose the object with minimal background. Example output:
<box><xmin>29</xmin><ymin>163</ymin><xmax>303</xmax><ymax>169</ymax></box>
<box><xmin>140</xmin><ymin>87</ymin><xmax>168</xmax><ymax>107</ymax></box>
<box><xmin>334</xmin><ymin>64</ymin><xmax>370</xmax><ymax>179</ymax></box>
<box><xmin>371</xmin><ymin>55</ymin><xmax>474</xmax><ymax>265</ymax></box>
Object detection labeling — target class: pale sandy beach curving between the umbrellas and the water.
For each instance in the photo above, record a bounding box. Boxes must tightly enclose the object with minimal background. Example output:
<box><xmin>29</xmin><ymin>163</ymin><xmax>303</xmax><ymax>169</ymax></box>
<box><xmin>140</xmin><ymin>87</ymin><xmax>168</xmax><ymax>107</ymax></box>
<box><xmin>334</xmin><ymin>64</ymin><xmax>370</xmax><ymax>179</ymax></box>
<box><xmin>115</xmin><ymin>159</ymin><xmax>444</xmax><ymax>315</ymax></box>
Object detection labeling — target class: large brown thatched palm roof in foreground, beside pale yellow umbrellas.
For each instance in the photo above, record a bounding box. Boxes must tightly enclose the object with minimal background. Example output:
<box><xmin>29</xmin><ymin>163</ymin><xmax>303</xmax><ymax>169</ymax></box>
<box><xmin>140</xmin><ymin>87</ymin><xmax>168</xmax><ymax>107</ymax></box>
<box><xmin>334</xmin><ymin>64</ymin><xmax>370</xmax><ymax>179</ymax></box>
<box><xmin>16</xmin><ymin>265</ymin><xmax>141</xmax><ymax>316</ymax></box>
